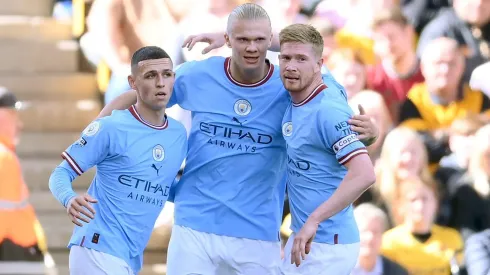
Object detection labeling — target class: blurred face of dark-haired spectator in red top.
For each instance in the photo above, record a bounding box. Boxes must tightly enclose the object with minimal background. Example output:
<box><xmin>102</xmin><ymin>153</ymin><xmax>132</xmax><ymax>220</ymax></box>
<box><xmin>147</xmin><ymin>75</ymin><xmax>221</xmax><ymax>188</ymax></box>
<box><xmin>373</xmin><ymin>21</ymin><xmax>414</xmax><ymax>62</ymax></box>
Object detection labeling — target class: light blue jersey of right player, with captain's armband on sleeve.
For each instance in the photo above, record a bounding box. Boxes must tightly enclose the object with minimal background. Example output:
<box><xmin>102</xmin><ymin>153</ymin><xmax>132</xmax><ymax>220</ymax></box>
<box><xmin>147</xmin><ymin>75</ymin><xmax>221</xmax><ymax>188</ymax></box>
<box><xmin>282</xmin><ymin>76</ymin><xmax>367</xmax><ymax>244</ymax></box>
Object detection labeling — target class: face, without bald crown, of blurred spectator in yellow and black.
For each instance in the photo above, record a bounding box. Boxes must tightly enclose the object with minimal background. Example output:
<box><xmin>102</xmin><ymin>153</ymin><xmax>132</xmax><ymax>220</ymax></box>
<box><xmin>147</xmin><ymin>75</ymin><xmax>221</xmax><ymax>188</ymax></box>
<box><xmin>421</xmin><ymin>47</ymin><xmax>464</xmax><ymax>96</ymax></box>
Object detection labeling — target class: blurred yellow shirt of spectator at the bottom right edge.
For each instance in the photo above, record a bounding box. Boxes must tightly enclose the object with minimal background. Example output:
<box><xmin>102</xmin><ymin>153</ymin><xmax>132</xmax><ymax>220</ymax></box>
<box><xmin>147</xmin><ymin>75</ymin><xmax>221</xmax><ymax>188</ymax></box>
<box><xmin>382</xmin><ymin>225</ymin><xmax>463</xmax><ymax>275</ymax></box>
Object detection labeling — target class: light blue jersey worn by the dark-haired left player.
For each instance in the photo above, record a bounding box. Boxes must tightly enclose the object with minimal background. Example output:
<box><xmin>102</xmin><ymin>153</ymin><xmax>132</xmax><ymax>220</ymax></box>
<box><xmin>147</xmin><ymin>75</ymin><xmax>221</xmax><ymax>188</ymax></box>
<box><xmin>62</xmin><ymin>105</ymin><xmax>187</xmax><ymax>273</ymax></box>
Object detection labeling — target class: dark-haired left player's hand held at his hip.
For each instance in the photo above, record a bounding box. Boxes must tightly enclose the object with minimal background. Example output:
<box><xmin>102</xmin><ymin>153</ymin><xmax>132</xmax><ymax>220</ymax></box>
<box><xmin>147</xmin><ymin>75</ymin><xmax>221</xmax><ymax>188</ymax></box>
<box><xmin>66</xmin><ymin>194</ymin><xmax>97</xmax><ymax>227</ymax></box>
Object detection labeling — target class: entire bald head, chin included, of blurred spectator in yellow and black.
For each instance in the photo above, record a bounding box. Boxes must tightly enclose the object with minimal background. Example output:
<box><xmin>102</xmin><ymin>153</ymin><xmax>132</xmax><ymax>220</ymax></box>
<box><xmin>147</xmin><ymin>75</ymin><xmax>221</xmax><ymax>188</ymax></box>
<box><xmin>422</xmin><ymin>38</ymin><xmax>465</xmax><ymax>103</ymax></box>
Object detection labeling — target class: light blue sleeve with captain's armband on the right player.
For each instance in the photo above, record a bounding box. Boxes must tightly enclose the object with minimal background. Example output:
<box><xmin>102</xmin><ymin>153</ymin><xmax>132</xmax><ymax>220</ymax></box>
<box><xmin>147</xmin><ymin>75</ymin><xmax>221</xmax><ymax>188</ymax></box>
<box><xmin>317</xmin><ymin>102</ymin><xmax>367</xmax><ymax>165</ymax></box>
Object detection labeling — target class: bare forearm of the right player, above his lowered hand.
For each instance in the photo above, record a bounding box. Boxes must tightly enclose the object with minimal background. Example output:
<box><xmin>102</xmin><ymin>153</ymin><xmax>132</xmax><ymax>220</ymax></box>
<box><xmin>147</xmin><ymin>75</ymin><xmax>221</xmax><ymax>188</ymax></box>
<box><xmin>310</xmin><ymin>171</ymin><xmax>374</xmax><ymax>223</ymax></box>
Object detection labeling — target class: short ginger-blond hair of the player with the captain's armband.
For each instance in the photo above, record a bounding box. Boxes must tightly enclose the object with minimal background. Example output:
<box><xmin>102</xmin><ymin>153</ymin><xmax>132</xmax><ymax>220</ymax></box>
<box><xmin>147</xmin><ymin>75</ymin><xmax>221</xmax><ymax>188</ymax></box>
<box><xmin>279</xmin><ymin>24</ymin><xmax>323</xmax><ymax>57</ymax></box>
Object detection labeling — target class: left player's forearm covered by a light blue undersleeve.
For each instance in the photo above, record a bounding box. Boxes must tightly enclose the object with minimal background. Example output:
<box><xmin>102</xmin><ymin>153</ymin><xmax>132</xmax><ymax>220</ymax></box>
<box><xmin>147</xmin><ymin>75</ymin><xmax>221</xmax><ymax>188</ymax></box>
<box><xmin>49</xmin><ymin>161</ymin><xmax>77</xmax><ymax>207</ymax></box>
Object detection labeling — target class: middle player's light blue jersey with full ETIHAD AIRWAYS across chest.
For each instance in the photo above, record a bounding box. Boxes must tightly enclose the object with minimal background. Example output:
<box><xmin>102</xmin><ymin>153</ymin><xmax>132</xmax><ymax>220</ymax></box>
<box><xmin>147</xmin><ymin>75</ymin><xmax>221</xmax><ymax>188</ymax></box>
<box><xmin>170</xmin><ymin>57</ymin><xmax>290</xmax><ymax>241</ymax></box>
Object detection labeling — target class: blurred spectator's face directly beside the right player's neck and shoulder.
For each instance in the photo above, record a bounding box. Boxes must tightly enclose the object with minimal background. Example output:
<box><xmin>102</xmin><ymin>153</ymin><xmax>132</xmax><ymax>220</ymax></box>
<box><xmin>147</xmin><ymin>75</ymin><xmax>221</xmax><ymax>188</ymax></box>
<box><xmin>331</xmin><ymin>60</ymin><xmax>366</xmax><ymax>98</ymax></box>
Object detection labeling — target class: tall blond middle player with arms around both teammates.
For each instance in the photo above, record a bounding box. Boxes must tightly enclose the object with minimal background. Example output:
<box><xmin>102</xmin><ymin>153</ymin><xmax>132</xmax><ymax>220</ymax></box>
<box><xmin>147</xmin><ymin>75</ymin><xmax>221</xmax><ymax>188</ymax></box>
<box><xmin>97</xmin><ymin>4</ymin><xmax>376</xmax><ymax>275</ymax></box>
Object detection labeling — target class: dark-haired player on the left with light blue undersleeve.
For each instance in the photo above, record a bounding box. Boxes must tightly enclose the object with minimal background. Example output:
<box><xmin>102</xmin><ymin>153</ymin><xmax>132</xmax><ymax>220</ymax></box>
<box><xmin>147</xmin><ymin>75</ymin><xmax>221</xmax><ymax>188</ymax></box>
<box><xmin>49</xmin><ymin>47</ymin><xmax>187</xmax><ymax>275</ymax></box>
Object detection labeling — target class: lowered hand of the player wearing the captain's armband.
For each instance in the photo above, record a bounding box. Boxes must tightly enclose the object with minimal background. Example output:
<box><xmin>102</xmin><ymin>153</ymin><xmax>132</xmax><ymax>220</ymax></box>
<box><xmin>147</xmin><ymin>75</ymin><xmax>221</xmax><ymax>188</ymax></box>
<box><xmin>291</xmin><ymin>219</ymin><xmax>319</xmax><ymax>266</ymax></box>
